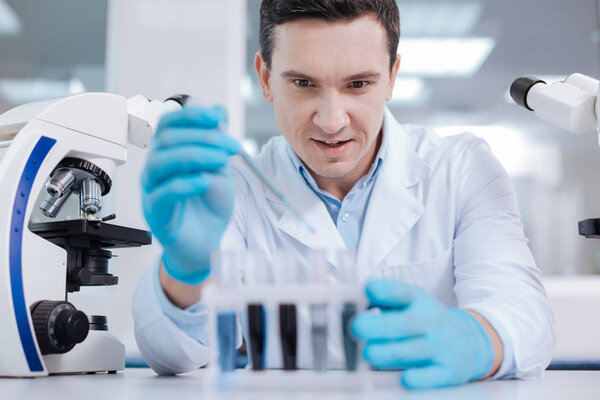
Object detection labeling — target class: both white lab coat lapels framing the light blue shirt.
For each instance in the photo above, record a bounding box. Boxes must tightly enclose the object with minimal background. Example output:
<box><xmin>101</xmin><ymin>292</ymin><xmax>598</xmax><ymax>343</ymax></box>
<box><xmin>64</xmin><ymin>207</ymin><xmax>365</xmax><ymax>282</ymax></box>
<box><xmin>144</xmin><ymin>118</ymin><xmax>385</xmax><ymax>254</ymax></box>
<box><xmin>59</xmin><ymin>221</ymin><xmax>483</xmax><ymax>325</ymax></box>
<box><xmin>266</xmin><ymin>109</ymin><xmax>429</xmax><ymax>268</ymax></box>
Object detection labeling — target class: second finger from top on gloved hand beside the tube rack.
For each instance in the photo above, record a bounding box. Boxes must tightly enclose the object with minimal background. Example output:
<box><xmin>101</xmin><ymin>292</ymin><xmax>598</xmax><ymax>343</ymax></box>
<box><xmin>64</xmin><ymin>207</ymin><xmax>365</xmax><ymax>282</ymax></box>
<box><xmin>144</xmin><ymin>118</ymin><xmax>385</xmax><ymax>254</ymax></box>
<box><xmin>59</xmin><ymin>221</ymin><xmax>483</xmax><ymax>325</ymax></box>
<box><xmin>351</xmin><ymin>309</ymin><xmax>429</xmax><ymax>340</ymax></box>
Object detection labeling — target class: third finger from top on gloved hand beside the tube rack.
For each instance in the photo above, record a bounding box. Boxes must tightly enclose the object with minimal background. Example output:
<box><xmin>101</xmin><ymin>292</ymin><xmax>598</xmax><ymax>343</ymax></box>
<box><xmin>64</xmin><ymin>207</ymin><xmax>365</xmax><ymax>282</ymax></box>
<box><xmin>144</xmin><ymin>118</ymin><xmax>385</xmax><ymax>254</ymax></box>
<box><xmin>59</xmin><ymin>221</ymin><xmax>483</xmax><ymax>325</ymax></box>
<box><xmin>363</xmin><ymin>337</ymin><xmax>434</xmax><ymax>369</ymax></box>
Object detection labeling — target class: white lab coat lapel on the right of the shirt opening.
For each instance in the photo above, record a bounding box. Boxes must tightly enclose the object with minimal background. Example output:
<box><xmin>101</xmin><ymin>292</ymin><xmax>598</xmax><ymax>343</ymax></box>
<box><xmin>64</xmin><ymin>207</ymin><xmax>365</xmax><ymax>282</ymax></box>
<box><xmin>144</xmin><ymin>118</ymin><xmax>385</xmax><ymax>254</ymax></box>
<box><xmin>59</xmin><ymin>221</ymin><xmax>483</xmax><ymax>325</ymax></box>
<box><xmin>356</xmin><ymin>110</ymin><xmax>430</xmax><ymax>275</ymax></box>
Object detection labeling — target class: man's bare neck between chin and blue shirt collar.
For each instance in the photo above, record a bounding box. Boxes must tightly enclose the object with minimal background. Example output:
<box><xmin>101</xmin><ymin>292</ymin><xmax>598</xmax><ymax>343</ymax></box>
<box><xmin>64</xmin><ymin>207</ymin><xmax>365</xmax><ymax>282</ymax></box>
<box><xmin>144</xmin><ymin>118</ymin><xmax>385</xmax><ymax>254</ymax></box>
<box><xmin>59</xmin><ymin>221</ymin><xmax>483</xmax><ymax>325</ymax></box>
<box><xmin>309</xmin><ymin>129</ymin><xmax>383</xmax><ymax>201</ymax></box>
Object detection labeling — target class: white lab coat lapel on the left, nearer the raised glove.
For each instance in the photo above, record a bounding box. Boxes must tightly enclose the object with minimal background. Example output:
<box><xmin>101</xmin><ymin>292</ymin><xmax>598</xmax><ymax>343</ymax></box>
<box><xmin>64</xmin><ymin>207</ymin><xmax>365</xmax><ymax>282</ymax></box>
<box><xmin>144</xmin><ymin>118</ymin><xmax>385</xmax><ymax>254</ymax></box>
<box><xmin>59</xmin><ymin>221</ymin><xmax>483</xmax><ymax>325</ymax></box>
<box><xmin>267</xmin><ymin>141</ymin><xmax>347</xmax><ymax>266</ymax></box>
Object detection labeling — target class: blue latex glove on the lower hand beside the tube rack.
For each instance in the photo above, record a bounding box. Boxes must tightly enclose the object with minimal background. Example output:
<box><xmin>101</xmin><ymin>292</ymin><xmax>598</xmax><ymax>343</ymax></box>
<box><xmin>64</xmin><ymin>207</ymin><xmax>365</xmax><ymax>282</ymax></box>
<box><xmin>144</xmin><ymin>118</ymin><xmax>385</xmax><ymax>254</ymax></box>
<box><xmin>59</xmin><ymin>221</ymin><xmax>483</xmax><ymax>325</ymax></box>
<box><xmin>352</xmin><ymin>279</ymin><xmax>494</xmax><ymax>389</ymax></box>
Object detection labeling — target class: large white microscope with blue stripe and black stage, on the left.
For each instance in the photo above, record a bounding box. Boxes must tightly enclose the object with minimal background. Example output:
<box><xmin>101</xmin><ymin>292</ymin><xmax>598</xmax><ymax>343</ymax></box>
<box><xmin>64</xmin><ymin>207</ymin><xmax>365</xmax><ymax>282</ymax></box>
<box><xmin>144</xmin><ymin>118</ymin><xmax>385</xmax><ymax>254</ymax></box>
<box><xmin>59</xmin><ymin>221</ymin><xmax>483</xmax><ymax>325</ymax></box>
<box><xmin>0</xmin><ymin>93</ymin><xmax>181</xmax><ymax>377</ymax></box>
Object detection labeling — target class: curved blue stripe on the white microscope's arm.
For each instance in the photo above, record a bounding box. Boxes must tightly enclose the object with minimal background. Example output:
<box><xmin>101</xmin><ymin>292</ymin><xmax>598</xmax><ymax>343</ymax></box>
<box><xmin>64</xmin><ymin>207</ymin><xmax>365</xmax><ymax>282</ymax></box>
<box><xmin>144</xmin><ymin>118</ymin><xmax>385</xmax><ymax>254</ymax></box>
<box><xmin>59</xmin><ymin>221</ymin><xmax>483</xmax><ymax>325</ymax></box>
<box><xmin>9</xmin><ymin>136</ymin><xmax>56</xmax><ymax>372</ymax></box>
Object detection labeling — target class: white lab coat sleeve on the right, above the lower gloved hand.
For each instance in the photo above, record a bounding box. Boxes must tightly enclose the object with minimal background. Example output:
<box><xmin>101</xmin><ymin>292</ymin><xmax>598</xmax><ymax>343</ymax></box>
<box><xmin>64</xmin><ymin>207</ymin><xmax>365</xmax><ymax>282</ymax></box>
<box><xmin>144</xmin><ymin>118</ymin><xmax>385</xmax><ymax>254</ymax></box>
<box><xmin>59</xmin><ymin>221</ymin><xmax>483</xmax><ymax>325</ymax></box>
<box><xmin>454</xmin><ymin>139</ymin><xmax>555</xmax><ymax>378</ymax></box>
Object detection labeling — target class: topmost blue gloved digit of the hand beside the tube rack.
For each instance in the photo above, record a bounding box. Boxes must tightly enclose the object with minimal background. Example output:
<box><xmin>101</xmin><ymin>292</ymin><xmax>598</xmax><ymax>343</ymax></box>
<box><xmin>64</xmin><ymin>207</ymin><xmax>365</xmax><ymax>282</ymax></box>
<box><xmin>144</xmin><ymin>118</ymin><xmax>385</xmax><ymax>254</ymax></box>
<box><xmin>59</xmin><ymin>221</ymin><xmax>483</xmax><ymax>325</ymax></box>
<box><xmin>366</xmin><ymin>279</ymin><xmax>423</xmax><ymax>308</ymax></box>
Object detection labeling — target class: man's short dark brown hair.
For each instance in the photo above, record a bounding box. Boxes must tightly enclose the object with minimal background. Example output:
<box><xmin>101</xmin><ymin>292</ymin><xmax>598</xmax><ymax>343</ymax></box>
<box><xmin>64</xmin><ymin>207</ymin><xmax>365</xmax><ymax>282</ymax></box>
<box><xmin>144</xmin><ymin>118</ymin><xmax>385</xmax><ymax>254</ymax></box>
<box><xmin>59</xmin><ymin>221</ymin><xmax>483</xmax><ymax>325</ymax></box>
<box><xmin>259</xmin><ymin>0</ymin><xmax>400</xmax><ymax>69</ymax></box>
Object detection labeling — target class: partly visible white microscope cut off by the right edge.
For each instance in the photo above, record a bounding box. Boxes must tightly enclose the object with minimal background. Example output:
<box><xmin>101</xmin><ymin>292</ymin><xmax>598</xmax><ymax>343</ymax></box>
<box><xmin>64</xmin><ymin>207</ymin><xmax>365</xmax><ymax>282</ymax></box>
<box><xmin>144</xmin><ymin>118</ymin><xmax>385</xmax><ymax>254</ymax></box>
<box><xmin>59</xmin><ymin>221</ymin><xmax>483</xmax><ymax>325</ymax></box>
<box><xmin>510</xmin><ymin>73</ymin><xmax>600</xmax><ymax>239</ymax></box>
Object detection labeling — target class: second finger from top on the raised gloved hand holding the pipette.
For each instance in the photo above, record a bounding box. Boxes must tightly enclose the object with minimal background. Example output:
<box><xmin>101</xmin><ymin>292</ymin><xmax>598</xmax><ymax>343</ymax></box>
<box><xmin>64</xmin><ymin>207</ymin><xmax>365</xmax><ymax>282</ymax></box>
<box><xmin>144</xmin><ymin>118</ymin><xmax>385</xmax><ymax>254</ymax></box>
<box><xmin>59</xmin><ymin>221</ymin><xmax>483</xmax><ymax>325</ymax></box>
<box><xmin>152</xmin><ymin>128</ymin><xmax>241</xmax><ymax>154</ymax></box>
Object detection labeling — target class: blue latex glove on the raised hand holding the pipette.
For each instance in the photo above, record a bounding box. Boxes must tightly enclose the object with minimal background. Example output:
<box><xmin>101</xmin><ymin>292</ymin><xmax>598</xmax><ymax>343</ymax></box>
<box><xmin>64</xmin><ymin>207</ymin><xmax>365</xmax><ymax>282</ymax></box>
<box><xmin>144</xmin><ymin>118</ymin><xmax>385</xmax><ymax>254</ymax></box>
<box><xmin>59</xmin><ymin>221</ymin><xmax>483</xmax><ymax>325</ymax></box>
<box><xmin>142</xmin><ymin>107</ymin><xmax>240</xmax><ymax>284</ymax></box>
